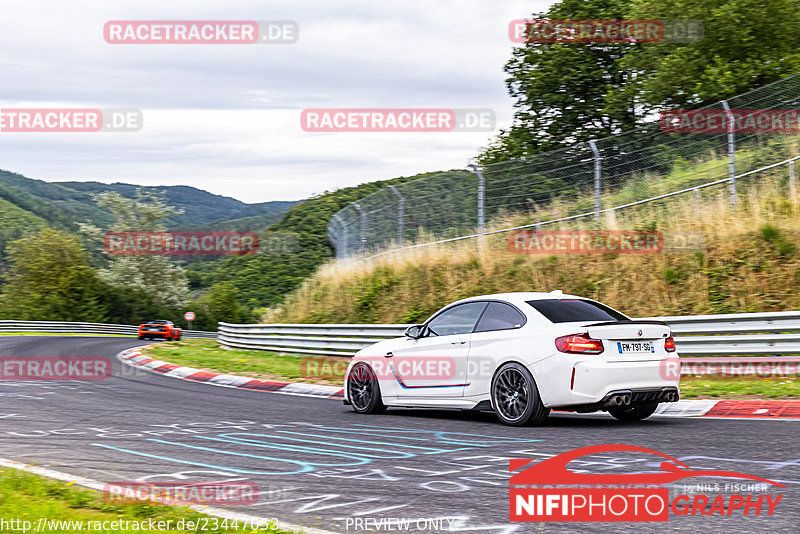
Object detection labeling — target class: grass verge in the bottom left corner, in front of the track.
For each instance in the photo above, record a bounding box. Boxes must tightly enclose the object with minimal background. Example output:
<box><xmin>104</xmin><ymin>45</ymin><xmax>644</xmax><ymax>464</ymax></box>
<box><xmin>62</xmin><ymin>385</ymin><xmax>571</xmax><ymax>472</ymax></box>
<box><xmin>0</xmin><ymin>469</ymin><xmax>282</xmax><ymax>534</ymax></box>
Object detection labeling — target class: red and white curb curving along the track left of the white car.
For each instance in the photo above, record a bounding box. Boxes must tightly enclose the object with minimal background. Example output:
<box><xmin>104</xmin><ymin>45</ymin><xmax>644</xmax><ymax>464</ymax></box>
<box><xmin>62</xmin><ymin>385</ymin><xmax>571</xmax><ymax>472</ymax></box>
<box><xmin>117</xmin><ymin>347</ymin><xmax>344</xmax><ymax>399</ymax></box>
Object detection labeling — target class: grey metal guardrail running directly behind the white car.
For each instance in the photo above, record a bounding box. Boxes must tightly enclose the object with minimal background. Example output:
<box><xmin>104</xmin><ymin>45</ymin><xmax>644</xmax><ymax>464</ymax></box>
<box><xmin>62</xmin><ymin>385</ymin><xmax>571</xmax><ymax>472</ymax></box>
<box><xmin>218</xmin><ymin>311</ymin><xmax>800</xmax><ymax>362</ymax></box>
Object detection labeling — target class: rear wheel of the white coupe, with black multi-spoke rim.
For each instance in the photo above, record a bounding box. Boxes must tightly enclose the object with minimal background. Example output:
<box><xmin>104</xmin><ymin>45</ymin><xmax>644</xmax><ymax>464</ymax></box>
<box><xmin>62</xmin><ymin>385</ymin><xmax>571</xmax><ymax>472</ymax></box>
<box><xmin>491</xmin><ymin>362</ymin><xmax>550</xmax><ymax>426</ymax></box>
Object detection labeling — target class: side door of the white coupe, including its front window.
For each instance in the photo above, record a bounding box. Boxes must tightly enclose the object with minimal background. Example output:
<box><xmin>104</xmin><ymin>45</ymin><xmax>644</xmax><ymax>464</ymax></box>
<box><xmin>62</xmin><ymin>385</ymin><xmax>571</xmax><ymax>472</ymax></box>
<box><xmin>389</xmin><ymin>301</ymin><xmax>486</xmax><ymax>399</ymax></box>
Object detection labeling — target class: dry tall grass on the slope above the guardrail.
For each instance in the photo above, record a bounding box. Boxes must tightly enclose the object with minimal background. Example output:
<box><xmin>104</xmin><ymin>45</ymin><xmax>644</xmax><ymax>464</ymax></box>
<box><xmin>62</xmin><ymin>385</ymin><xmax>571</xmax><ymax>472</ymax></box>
<box><xmin>262</xmin><ymin>168</ymin><xmax>800</xmax><ymax>323</ymax></box>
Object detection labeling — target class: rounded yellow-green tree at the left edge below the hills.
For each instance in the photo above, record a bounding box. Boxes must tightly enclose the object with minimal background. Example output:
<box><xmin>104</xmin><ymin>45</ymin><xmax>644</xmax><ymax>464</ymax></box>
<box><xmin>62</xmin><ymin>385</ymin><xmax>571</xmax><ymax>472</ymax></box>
<box><xmin>0</xmin><ymin>228</ymin><xmax>106</xmax><ymax>322</ymax></box>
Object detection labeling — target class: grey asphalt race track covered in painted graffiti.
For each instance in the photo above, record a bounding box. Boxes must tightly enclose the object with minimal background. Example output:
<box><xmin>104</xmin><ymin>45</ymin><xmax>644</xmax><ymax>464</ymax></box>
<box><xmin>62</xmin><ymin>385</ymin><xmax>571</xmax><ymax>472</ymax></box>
<box><xmin>0</xmin><ymin>336</ymin><xmax>800</xmax><ymax>533</ymax></box>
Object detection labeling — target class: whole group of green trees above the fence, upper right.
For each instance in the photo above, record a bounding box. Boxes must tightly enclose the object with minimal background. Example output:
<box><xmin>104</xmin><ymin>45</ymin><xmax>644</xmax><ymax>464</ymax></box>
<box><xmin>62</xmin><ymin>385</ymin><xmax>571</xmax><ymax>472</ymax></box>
<box><xmin>477</xmin><ymin>0</ymin><xmax>800</xmax><ymax>164</ymax></box>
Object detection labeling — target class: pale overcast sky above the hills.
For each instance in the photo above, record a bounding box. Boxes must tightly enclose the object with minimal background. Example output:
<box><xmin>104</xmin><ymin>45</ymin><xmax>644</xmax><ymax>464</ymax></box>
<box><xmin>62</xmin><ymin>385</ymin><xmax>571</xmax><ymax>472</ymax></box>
<box><xmin>0</xmin><ymin>0</ymin><xmax>552</xmax><ymax>202</ymax></box>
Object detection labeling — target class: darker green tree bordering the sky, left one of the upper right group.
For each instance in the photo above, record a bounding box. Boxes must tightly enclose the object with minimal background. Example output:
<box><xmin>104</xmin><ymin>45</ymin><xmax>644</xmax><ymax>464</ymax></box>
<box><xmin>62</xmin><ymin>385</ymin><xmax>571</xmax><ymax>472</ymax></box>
<box><xmin>478</xmin><ymin>0</ymin><xmax>641</xmax><ymax>164</ymax></box>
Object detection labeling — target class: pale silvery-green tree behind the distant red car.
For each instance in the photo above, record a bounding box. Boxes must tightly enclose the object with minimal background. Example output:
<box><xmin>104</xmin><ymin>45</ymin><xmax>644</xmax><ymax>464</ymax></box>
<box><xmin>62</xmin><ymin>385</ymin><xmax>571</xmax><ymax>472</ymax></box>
<box><xmin>81</xmin><ymin>189</ymin><xmax>189</xmax><ymax>308</ymax></box>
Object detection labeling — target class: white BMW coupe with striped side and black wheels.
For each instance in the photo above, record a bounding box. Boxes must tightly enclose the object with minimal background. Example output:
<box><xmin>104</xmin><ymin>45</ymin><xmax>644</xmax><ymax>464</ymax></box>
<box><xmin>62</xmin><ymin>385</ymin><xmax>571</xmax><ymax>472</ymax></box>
<box><xmin>344</xmin><ymin>291</ymin><xmax>680</xmax><ymax>426</ymax></box>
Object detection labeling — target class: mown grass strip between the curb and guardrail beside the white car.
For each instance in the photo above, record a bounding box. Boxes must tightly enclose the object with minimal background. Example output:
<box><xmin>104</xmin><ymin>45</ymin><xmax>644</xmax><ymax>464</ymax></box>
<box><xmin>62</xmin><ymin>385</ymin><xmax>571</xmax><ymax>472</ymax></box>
<box><xmin>143</xmin><ymin>339</ymin><xmax>800</xmax><ymax>399</ymax></box>
